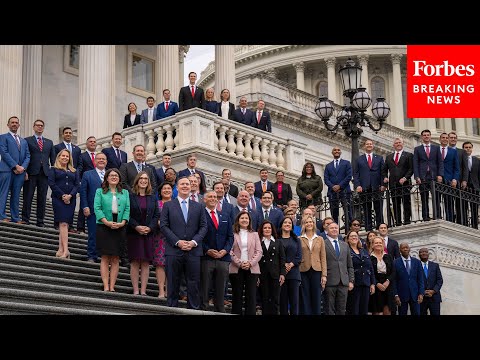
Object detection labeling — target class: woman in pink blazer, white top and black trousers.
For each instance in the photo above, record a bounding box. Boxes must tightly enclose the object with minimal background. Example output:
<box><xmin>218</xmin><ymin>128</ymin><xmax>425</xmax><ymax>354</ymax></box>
<box><xmin>229</xmin><ymin>212</ymin><xmax>262</xmax><ymax>315</ymax></box>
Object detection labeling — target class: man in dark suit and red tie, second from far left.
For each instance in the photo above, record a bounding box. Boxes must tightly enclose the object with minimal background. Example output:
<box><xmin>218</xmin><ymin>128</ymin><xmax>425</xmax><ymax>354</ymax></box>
<box><xmin>22</xmin><ymin>119</ymin><xmax>55</xmax><ymax>227</ymax></box>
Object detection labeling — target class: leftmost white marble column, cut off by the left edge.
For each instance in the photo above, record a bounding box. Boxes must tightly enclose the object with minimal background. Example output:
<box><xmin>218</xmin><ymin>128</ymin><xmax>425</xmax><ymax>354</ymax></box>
<box><xmin>0</xmin><ymin>45</ymin><xmax>25</xmax><ymax>134</ymax></box>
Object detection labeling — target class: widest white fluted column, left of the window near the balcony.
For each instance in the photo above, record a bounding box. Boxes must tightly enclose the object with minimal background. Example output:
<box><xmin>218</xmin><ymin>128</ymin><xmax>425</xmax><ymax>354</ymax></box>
<box><xmin>77</xmin><ymin>45</ymin><xmax>115</xmax><ymax>144</ymax></box>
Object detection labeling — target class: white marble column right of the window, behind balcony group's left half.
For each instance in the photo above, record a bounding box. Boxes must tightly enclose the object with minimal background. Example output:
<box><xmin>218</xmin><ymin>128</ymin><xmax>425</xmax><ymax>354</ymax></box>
<box><xmin>156</xmin><ymin>45</ymin><xmax>180</xmax><ymax>103</ymax></box>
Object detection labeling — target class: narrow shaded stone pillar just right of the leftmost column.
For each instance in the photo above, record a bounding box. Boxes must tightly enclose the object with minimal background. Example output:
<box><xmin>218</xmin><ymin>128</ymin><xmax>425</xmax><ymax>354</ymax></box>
<box><xmin>20</xmin><ymin>45</ymin><xmax>42</xmax><ymax>136</ymax></box>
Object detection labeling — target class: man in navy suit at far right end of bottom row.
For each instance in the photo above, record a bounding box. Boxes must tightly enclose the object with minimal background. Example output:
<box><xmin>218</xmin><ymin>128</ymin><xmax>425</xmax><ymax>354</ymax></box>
<box><xmin>418</xmin><ymin>248</ymin><xmax>443</xmax><ymax>315</ymax></box>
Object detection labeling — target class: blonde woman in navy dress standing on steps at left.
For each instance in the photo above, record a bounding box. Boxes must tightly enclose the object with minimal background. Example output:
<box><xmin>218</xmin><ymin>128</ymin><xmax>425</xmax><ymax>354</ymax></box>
<box><xmin>48</xmin><ymin>149</ymin><xmax>80</xmax><ymax>259</ymax></box>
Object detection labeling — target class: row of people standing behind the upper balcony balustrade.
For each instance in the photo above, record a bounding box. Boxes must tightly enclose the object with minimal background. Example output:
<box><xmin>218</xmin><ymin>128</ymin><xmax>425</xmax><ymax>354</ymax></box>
<box><xmin>123</xmin><ymin>71</ymin><xmax>272</xmax><ymax>132</ymax></box>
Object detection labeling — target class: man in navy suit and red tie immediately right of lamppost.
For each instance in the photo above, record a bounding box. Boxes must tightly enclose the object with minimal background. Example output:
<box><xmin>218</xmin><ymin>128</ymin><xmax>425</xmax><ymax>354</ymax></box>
<box><xmin>353</xmin><ymin>139</ymin><xmax>385</xmax><ymax>231</ymax></box>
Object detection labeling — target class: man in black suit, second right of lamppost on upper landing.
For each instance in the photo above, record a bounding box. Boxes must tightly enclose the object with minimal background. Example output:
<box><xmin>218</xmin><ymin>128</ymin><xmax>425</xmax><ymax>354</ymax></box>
<box><xmin>382</xmin><ymin>138</ymin><xmax>413</xmax><ymax>226</ymax></box>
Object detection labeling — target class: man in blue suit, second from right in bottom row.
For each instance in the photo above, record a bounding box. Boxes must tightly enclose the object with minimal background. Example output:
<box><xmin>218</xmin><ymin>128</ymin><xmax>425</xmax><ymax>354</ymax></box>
<box><xmin>392</xmin><ymin>242</ymin><xmax>425</xmax><ymax>315</ymax></box>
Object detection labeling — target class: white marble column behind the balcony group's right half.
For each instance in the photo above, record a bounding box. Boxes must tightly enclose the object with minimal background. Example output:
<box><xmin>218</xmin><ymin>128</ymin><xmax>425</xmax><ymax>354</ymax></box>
<box><xmin>215</xmin><ymin>45</ymin><xmax>237</xmax><ymax>104</ymax></box>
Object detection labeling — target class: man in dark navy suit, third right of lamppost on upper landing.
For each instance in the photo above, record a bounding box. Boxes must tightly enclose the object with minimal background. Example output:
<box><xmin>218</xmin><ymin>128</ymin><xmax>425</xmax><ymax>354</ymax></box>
<box><xmin>413</xmin><ymin>130</ymin><xmax>443</xmax><ymax>221</ymax></box>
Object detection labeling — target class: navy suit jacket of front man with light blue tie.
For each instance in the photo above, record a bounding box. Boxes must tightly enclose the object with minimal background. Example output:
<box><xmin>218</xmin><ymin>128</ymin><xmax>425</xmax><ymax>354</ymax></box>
<box><xmin>160</xmin><ymin>199</ymin><xmax>208</xmax><ymax>256</ymax></box>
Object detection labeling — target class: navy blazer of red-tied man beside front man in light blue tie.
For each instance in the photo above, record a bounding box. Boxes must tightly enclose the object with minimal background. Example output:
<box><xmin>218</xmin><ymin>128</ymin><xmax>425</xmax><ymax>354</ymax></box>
<box><xmin>203</xmin><ymin>208</ymin><xmax>233</xmax><ymax>261</ymax></box>
